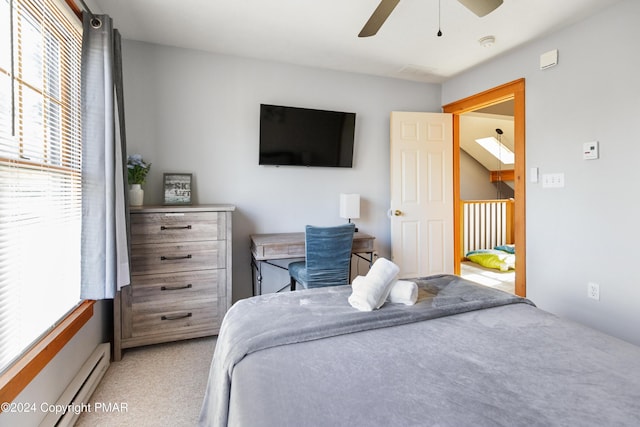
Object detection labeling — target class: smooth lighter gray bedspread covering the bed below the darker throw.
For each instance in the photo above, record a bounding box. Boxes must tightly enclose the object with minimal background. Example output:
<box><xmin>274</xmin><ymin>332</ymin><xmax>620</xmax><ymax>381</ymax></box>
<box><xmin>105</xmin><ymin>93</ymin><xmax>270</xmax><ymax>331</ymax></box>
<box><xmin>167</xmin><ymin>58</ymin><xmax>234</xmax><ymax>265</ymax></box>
<box><xmin>228</xmin><ymin>304</ymin><xmax>640</xmax><ymax>427</ymax></box>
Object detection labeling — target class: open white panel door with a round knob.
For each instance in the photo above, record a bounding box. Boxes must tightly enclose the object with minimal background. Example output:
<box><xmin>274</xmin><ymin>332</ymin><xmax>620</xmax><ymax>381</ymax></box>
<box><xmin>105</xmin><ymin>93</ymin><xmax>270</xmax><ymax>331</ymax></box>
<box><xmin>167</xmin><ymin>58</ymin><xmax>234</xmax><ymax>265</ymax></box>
<box><xmin>389</xmin><ymin>111</ymin><xmax>453</xmax><ymax>278</ymax></box>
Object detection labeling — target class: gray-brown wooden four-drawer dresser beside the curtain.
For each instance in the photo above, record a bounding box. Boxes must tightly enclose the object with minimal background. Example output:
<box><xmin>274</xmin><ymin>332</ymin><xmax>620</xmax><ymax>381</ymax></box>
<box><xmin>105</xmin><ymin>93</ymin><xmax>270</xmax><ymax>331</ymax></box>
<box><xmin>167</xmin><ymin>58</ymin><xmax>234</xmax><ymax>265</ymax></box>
<box><xmin>113</xmin><ymin>205</ymin><xmax>235</xmax><ymax>361</ymax></box>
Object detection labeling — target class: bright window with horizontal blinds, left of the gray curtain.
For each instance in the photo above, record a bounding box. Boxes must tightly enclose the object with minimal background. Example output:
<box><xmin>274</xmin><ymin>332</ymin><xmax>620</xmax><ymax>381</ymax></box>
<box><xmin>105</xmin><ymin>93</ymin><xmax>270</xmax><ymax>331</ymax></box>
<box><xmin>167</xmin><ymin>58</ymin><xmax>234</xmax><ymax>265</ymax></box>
<box><xmin>0</xmin><ymin>0</ymin><xmax>82</xmax><ymax>371</ymax></box>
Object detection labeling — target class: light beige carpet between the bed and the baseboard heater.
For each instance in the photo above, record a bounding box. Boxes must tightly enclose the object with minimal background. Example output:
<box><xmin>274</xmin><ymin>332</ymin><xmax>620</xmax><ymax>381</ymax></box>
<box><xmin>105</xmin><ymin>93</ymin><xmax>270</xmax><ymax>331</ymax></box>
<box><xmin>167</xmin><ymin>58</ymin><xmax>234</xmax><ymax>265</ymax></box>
<box><xmin>76</xmin><ymin>337</ymin><xmax>216</xmax><ymax>427</ymax></box>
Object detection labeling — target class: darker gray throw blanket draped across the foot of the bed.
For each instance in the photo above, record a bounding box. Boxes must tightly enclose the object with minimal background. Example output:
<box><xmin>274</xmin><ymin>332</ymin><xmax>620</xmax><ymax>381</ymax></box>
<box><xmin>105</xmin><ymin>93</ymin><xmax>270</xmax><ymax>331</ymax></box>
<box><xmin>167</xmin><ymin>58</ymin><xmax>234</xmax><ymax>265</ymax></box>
<box><xmin>199</xmin><ymin>275</ymin><xmax>531</xmax><ymax>426</ymax></box>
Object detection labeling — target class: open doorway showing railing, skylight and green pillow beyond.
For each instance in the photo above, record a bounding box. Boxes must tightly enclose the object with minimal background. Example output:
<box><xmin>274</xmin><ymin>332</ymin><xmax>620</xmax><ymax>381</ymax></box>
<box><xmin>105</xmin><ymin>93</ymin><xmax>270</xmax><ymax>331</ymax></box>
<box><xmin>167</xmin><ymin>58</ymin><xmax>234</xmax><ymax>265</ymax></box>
<box><xmin>459</xmin><ymin>99</ymin><xmax>516</xmax><ymax>294</ymax></box>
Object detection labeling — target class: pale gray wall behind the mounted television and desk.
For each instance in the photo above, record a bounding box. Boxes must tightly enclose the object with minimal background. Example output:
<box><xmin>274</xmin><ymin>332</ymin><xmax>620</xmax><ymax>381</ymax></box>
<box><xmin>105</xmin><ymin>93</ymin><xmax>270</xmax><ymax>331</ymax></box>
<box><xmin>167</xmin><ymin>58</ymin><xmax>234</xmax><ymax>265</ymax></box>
<box><xmin>123</xmin><ymin>41</ymin><xmax>441</xmax><ymax>300</ymax></box>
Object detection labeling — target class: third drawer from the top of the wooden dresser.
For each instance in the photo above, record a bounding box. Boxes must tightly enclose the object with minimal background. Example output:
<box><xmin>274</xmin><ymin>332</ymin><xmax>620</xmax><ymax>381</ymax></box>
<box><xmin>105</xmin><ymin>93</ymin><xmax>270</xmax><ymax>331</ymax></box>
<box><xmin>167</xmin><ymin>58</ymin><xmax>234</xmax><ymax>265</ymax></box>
<box><xmin>131</xmin><ymin>269</ymin><xmax>226</xmax><ymax>305</ymax></box>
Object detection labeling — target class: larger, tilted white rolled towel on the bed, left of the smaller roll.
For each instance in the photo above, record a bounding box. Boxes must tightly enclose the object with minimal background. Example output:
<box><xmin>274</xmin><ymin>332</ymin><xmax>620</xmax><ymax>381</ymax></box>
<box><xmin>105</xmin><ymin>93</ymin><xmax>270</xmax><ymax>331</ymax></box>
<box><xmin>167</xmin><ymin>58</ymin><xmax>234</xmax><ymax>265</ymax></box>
<box><xmin>349</xmin><ymin>258</ymin><xmax>400</xmax><ymax>311</ymax></box>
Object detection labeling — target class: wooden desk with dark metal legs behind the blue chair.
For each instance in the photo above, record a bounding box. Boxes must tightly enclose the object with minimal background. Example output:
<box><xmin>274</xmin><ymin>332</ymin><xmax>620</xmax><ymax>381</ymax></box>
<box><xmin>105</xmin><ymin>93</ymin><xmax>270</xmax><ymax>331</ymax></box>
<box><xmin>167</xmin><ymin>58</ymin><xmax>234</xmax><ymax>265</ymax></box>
<box><xmin>250</xmin><ymin>231</ymin><xmax>375</xmax><ymax>295</ymax></box>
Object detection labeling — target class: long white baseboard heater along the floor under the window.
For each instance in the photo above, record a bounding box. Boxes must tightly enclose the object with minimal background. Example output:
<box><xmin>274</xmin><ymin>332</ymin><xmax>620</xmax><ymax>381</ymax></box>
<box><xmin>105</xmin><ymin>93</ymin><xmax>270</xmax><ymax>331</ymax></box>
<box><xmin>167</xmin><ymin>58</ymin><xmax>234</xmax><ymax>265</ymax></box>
<box><xmin>40</xmin><ymin>343</ymin><xmax>111</xmax><ymax>427</ymax></box>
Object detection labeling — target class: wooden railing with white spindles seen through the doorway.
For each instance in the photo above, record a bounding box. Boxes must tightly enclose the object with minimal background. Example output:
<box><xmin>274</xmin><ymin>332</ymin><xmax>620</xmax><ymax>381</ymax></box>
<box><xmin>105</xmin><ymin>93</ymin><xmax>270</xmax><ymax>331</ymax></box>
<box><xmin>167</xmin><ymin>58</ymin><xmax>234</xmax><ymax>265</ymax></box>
<box><xmin>461</xmin><ymin>199</ymin><xmax>514</xmax><ymax>258</ymax></box>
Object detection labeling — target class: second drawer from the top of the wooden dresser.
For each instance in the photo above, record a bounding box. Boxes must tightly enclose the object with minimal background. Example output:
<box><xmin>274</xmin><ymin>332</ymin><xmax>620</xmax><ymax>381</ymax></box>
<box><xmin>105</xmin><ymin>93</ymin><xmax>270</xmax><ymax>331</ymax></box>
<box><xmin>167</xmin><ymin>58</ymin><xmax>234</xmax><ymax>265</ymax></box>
<box><xmin>131</xmin><ymin>240</ymin><xmax>226</xmax><ymax>275</ymax></box>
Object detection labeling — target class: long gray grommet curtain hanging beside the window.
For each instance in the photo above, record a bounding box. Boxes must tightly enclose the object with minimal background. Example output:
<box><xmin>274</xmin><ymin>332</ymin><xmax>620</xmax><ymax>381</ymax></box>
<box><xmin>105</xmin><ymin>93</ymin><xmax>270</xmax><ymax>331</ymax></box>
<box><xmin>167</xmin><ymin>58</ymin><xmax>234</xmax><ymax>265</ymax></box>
<box><xmin>80</xmin><ymin>12</ymin><xmax>129</xmax><ymax>299</ymax></box>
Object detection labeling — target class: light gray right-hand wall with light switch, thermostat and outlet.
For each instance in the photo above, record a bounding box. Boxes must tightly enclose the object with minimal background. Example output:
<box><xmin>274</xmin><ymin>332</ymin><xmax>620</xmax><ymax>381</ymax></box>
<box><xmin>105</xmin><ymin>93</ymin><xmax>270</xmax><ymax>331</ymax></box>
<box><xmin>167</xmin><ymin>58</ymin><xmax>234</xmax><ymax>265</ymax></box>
<box><xmin>442</xmin><ymin>0</ymin><xmax>640</xmax><ymax>344</ymax></box>
